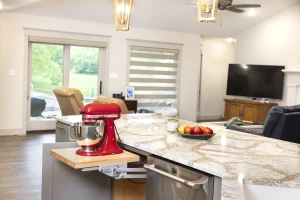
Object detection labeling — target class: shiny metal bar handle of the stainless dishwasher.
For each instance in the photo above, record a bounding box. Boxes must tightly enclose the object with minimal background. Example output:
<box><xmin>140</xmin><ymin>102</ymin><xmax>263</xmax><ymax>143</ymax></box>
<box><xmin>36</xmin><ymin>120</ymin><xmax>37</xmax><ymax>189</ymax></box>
<box><xmin>144</xmin><ymin>164</ymin><xmax>208</xmax><ymax>190</ymax></box>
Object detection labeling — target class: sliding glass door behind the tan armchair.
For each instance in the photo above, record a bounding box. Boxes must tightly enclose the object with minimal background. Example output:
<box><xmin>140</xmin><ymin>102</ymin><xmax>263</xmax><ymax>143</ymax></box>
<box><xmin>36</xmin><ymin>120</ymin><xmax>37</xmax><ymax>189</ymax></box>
<box><xmin>27</xmin><ymin>42</ymin><xmax>105</xmax><ymax>131</ymax></box>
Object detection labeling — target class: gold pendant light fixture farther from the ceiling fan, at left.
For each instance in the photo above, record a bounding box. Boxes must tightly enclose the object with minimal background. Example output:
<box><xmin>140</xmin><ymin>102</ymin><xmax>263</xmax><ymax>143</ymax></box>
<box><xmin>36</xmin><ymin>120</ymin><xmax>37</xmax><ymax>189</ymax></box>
<box><xmin>114</xmin><ymin>0</ymin><xmax>133</xmax><ymax>31</ymax></box>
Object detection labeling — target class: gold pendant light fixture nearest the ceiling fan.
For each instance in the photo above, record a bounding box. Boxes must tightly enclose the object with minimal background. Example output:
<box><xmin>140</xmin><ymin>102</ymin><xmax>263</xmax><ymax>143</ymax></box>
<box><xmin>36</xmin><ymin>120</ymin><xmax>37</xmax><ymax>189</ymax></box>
<box><xmin>197</xmin><ymin>0</ymin><xmax>219</xmax><ymax>22</ymax></box>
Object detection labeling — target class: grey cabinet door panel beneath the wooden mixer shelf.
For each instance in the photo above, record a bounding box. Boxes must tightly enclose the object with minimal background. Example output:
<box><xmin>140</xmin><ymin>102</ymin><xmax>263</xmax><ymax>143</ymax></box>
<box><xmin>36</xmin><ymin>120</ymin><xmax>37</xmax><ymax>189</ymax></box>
<box><xmin>42</xmin><ymin>142</ymin><xmax>113</xmax><ymax>200</ymax></box>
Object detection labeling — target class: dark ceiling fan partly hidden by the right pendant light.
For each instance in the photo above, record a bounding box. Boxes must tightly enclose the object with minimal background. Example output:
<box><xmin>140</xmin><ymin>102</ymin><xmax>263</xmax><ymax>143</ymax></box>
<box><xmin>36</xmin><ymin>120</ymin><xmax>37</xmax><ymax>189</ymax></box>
<box><xmin>187</xmin><ymin>0</ymin><xmax>261</xmax><ymax>13</ymax></box>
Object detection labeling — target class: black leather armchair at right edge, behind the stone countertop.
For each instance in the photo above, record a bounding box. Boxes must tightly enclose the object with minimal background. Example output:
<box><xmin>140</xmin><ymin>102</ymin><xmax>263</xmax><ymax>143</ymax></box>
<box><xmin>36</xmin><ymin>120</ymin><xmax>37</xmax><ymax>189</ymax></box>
<box><xmin>227</xmin><ymin>105</ymin><xmax>300</xmax><ymax>144</ymax></box>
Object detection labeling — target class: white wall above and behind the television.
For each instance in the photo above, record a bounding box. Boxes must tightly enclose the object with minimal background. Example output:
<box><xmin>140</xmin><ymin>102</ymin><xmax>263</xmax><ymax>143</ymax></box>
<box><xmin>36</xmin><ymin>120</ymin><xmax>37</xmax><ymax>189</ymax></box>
<box><xmin>235</xmin><ymin>4</ymin><xmax>300</xmax><ymax>104</ymax></box>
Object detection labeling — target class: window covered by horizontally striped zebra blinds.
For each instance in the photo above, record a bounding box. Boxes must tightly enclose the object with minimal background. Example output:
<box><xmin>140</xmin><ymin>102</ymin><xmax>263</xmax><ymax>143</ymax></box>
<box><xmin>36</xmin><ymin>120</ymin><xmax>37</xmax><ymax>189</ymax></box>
<box><xmin>129</xmin><ymin>46</ymin><xmax>179</xmax><ymax>111</ymax></box>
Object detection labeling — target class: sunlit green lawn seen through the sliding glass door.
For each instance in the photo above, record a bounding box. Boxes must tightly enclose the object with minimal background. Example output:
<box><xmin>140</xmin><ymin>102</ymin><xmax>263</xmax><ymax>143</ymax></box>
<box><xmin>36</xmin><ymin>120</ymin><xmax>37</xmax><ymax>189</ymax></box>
<box><xmin>32</xmin><ymin>74</ymin><xmax>98</xmax><ymax>97</ymax></box>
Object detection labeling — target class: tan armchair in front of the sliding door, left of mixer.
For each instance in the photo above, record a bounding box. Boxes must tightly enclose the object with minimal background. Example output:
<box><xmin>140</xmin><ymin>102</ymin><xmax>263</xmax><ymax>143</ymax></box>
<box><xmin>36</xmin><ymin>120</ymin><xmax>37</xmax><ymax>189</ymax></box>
<box><xmin>53</xmin><ymin>87</ymin><xmax>84</xmax><ymax>116</ymax></box>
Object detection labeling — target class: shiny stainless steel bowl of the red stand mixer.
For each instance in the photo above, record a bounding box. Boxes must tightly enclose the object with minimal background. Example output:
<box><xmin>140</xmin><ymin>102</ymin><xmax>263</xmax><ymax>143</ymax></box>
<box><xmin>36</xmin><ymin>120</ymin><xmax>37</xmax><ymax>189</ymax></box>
<box><xmin>74</xmin><ymin>122</ymin><xmax>104</xmax><ymax>149</ymax></box>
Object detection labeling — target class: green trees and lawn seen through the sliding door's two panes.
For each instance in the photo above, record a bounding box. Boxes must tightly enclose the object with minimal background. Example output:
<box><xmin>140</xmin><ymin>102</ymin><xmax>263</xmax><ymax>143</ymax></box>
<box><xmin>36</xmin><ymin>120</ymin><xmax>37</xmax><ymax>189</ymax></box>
<box><xmin>32</xmin><ymin>43</ymin><xmax>98</xmax><ymax>97</ymax></box>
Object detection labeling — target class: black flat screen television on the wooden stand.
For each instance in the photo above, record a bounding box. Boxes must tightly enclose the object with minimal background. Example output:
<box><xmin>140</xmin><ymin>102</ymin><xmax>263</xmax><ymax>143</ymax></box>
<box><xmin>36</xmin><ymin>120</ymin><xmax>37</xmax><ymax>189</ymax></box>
<box><xmin>226</xmin><ymin>64</ymin><xmax>284</xmax><ymax>99</ymax></box>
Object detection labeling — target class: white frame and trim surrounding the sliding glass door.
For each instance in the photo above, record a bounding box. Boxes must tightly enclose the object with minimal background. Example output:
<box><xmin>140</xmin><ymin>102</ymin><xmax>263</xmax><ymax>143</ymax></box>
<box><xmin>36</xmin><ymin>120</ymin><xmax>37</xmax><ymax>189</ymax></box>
<box><xmin>22</xmin><ymin>27</ymin><xmax>111</xmax><ymax>131</ymax></box>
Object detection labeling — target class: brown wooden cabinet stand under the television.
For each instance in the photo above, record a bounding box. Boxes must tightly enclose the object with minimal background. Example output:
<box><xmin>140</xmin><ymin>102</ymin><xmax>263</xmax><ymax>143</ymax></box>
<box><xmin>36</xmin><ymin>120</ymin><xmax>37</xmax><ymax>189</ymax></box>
<box><xmin>224</xmin><ymin>99</ymin><xmax>278</xmax><ymax>124</ymax></box>
